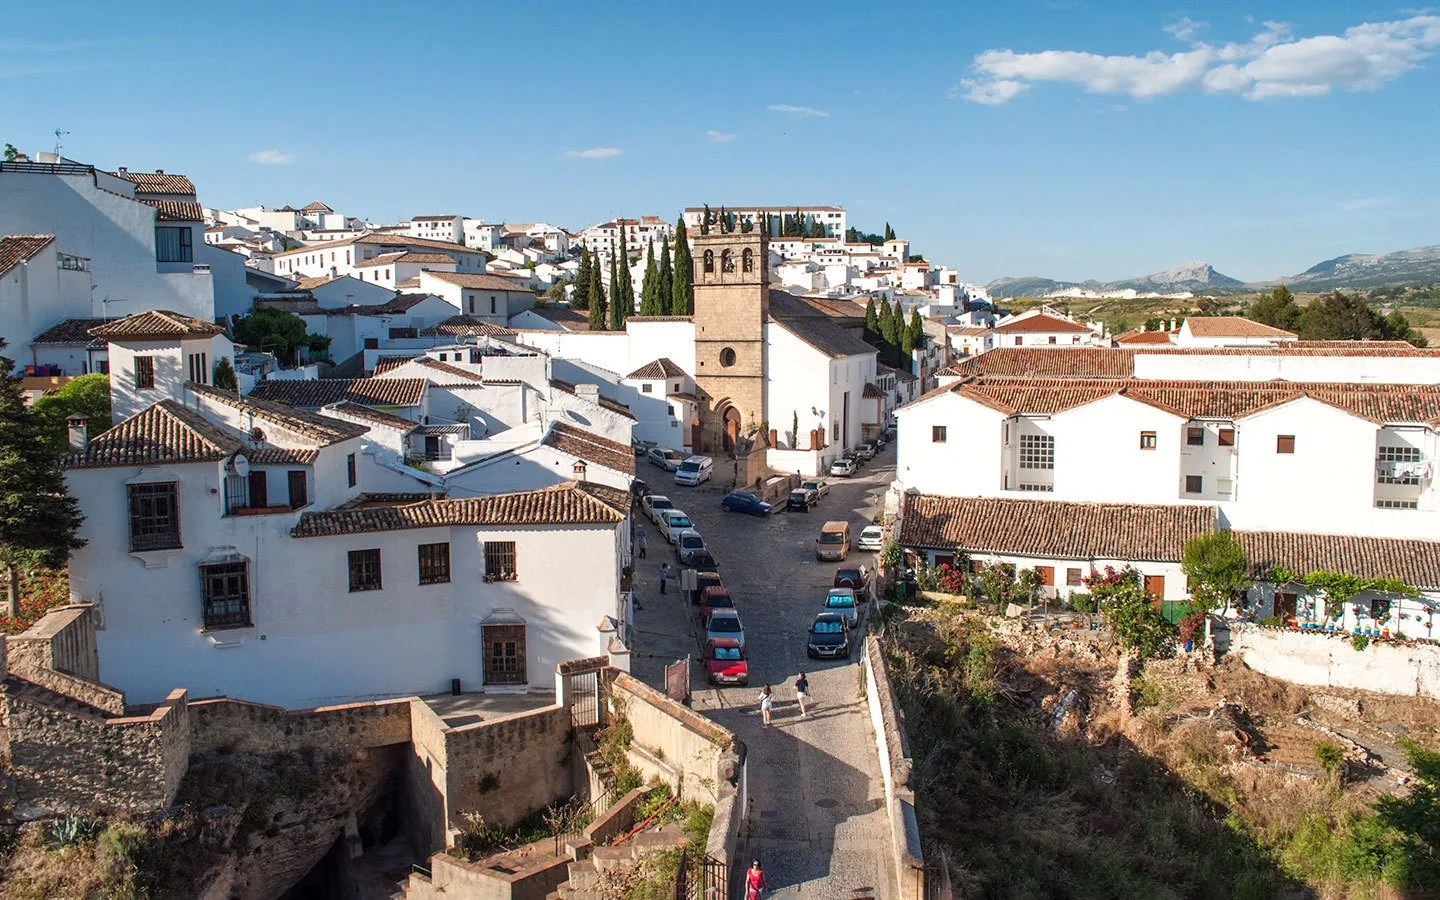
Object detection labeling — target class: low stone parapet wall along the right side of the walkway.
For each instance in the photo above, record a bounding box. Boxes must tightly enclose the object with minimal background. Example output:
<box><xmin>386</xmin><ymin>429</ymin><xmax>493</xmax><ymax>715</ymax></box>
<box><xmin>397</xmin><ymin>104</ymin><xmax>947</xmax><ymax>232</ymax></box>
<box><xmin>864</xmin><ymin>638</ymin><xmax>926</xmax><ymax>900</ymax></box>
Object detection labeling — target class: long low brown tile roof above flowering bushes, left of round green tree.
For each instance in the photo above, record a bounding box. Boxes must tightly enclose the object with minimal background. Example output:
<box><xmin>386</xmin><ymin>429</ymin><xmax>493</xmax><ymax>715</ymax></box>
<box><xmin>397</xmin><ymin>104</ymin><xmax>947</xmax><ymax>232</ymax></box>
<box><xmin>899</xmin><ymin>494</ymin><xmax>1215</xmax><ymax>562</ymax></box>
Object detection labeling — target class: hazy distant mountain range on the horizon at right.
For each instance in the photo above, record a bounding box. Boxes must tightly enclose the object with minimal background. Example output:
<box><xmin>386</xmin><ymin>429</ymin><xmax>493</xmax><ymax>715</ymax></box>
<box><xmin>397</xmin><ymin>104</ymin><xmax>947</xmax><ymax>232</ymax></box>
<box><xmin>985</xmin><ymin>245</ymin><xmax>1440</xmax><ymax>297</ymax></box>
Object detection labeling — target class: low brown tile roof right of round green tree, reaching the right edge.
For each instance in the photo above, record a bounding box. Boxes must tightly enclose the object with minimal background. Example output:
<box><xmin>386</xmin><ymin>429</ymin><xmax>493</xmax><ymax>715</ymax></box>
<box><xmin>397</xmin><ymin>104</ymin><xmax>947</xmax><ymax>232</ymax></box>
<box><xmin>1236</xmin><ymin>531</ymin><xmax>1440</xmax><ymax>590</ymax></box>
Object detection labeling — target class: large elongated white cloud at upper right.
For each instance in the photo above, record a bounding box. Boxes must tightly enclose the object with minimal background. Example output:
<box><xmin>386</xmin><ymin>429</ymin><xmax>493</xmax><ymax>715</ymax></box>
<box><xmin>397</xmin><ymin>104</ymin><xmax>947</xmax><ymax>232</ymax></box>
<box><xmin>952</xmin><ymin>16</ymin><xmax>1440</xmax><ymax>105</ymax></box>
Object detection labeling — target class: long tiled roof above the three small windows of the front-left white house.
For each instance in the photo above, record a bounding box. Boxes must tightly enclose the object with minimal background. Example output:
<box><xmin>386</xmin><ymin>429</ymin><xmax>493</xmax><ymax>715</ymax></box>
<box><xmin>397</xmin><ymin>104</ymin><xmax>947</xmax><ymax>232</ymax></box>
<box><xmin>291</xmin><ymin>482</ymin><xmax>625</xmax><ymax>535</ymax></box>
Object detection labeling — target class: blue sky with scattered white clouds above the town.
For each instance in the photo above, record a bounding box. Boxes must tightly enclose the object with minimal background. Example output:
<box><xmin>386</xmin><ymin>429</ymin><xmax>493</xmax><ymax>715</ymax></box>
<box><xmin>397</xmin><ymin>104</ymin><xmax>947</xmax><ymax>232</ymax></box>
<box><xmin>0</xmin><ymin>0</ymin><xmax>1440</xmax><ymax>281</ymax></box>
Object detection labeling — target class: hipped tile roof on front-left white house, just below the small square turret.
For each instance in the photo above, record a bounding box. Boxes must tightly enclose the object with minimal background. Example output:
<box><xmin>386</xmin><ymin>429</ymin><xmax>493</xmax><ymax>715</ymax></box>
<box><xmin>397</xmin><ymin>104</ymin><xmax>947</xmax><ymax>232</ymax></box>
<box><xmin>63</xmin><ymin>400</ymin><xmax>245</xmax><ymax>469</ymax></box>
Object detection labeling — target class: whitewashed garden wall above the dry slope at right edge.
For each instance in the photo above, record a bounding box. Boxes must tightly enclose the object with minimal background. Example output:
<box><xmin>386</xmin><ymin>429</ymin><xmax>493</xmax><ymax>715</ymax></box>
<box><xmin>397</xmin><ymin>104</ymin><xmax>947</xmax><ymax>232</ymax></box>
<box><xmin>1227</xmin><ymin>622</ymin><xmax>1440</xmax><ymax>700</ymax></box>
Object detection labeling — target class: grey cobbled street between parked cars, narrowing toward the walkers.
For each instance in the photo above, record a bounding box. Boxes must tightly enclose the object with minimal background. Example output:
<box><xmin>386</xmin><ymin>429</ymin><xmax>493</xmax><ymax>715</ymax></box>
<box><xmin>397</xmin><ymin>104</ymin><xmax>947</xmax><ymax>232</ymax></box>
<box><xmin>632</xmin><ymin>449</ymin><xmax>897</xmax><ymax>900</ymax></box>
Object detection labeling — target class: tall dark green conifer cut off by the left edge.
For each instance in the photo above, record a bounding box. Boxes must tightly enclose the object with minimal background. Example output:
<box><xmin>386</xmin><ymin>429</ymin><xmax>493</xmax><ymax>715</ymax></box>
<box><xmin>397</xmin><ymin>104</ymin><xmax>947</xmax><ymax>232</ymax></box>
<box><xmin>0</xmin><ymin>338</ymin><xmax>85</xmax><ymax>616</ymax></box>
